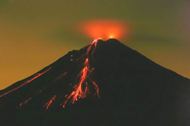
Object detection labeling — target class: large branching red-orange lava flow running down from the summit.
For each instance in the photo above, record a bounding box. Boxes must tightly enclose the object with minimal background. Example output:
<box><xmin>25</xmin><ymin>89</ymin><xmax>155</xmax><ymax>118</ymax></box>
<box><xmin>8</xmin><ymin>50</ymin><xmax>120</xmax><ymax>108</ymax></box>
<box><xmin>62</xmin><ymin>40</ymin><xmax>99</xmax><ymax>108</ymax></box>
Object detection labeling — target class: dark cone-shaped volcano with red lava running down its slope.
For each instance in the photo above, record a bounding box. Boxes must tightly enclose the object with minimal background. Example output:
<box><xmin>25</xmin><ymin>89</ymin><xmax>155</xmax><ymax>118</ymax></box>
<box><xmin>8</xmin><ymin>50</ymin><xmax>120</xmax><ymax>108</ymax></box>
<box><xmin>0</xmin><ymin>39</ymin><xmax>190</xmax><ymax>126</ymax></box>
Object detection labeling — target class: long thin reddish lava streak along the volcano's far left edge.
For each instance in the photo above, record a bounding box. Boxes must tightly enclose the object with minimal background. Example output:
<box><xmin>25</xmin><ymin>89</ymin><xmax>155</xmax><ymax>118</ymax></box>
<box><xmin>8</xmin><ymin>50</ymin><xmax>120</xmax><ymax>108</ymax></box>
<box><xmin>0</xmin><ymin>67</ymin><xmax>51</xmax><ymax>98</ymax></box>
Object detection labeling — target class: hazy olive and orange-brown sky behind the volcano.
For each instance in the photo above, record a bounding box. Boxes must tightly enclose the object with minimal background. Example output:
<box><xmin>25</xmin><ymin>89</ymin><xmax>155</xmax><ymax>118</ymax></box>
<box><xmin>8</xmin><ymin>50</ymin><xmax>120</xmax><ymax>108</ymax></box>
<box><xmin>0</xmin><ymin>0</ymin><xmax>190</xmax><ymax>89</ymax></box>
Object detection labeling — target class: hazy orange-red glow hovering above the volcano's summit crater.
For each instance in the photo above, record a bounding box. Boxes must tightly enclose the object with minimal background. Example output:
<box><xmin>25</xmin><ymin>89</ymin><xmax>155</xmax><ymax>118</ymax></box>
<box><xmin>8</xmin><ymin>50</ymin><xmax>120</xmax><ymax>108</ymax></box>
<box><xmin>80</xmin><ymin>20</ymin><xmax>128</xmax><ymax>39</ymax></box>
